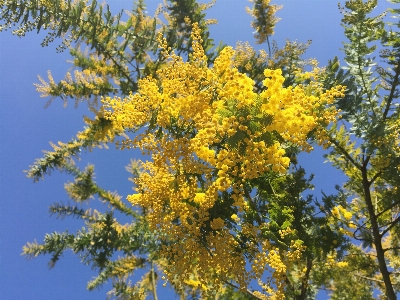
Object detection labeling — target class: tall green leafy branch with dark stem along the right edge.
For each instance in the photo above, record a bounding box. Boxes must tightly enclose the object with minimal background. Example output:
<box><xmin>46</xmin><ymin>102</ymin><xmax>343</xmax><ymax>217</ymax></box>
<box><xmin>326</xmin><ymin>0</ymin><xmax>400</xmax><ymax>299</ymax></box>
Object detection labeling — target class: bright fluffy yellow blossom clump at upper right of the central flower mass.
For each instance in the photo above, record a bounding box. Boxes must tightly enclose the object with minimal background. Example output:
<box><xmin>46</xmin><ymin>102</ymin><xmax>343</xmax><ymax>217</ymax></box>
<box><xmin>261</xmin><ymin>69</ymin><xmax>344</xmax><ymax>151</ymax></box>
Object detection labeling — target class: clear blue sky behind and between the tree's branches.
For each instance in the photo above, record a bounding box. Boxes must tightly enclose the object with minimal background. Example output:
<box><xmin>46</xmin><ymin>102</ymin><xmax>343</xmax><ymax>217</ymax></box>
<box><xmin>0</xmin><ymin>0</ymin><xmax>390</xmax><ymax>300</ymax></box>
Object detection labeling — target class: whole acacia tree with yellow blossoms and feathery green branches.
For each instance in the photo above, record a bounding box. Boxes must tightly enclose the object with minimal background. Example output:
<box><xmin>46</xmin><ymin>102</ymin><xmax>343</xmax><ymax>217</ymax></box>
<box><xmin>1</xmin><ymin>0</ymin><xmax>399</xmax><ymax>299</ymax></box>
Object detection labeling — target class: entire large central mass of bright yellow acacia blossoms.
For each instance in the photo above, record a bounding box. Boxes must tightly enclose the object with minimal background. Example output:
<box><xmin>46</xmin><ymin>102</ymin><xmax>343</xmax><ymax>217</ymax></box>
<box><xmin>103</xmin><ymin>24</ymin><xmax>341</xmax><ymax>293</ymax></box>
